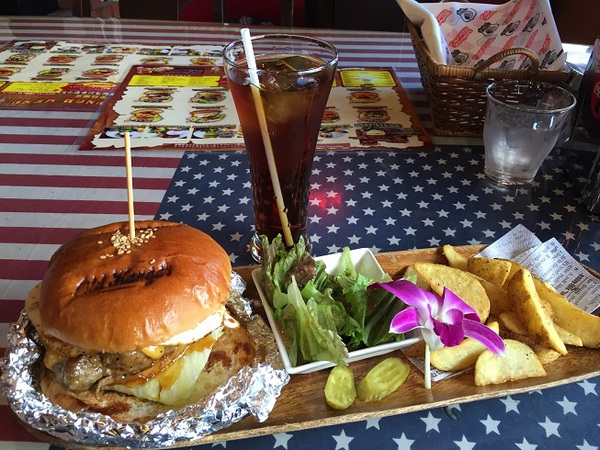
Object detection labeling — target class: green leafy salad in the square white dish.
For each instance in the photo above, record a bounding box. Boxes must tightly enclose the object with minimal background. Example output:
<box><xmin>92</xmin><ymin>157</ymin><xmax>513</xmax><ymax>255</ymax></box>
<box><xmin>262</xmin><ymin>236</ymin><xmax>406</xmax><ymax>366</ymax></box>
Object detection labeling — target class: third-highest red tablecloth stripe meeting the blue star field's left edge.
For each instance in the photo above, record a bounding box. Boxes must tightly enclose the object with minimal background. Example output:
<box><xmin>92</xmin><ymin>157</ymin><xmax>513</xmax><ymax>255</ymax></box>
<box><xmin>2</xmin><ymin>198</ymin><xmax>160</xmax><ymax>216</ymax></box>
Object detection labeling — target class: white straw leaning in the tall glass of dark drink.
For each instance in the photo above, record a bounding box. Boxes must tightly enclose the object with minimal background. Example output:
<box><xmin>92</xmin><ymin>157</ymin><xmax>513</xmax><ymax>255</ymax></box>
<box><xmin>241</xmin><ymin>28</ymin><xmax>294</xmax><ymax>247</ymax></box>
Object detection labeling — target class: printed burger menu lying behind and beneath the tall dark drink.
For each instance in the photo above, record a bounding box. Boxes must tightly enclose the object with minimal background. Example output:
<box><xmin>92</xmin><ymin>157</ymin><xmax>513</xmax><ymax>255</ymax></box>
<box><xmin>80</xmin><ymin>65</ymin><xmax>431</xmax><ymax>150</ymax></box>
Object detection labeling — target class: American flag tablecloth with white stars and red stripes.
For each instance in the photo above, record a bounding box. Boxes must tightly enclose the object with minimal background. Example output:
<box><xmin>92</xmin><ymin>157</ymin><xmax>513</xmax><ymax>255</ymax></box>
<box><xmin>0</xmin><ymin>18</ymin><xmax>600</xmax><ymax>450</ymax></box>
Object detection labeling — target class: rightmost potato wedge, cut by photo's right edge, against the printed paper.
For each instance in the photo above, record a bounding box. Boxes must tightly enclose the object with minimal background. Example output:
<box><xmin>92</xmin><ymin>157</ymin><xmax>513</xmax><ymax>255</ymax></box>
<box><xmin>536</xmin><ymin>282</ymin><xmax>600</xmax><ymax>348</ymax></box>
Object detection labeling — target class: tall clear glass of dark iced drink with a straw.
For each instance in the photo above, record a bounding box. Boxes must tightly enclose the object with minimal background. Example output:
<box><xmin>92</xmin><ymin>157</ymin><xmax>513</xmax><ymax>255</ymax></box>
<box><xmin>223</xmin><ymin>34</ymin><xmax>338</xmax><ymax>261</ymax></box>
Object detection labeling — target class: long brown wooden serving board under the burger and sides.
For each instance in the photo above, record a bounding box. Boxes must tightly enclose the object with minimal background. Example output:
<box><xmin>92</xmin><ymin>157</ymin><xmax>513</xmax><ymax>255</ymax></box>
<box><xmin>18</xmin><ymin>246</ymin><xmax>600</xmax><ymax>449</ymax></box>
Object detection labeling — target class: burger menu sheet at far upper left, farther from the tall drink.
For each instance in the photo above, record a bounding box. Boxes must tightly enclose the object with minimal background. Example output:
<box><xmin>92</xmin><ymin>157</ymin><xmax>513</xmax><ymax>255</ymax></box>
<box><xmin>0</xmin><ymin>41</ymin><xmax>222</xmax><ymax>111</ymax></box>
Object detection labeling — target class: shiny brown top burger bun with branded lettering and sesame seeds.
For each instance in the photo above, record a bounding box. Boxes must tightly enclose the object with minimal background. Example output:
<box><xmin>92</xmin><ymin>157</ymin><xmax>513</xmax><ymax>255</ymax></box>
<box><xmin>39</xmin><ymin>221</ymin><xmax>231</xmax><ymax>353</ymax></box>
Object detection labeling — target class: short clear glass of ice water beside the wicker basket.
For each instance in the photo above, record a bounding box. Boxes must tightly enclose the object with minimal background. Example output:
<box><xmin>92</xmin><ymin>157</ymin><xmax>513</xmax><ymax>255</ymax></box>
<box><xmin>483</xmin><ymin>80</ymin><xmax>576</xmax><ymax>185</ymax></box>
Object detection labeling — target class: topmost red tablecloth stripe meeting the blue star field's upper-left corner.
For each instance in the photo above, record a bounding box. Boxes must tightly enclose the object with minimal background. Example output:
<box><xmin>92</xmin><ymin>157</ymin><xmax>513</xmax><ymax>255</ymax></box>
<box><xmin>0</xmin><ymin>155</ymin><xmax>181</xmax><ymax>169</ymax></box>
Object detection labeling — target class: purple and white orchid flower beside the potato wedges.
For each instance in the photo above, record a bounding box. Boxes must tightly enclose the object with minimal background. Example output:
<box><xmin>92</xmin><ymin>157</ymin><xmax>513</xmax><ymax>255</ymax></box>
<box><xmin>368</xmin><ymin>280</ymin><xmax>505</xmax><ymax>355</ymax></box>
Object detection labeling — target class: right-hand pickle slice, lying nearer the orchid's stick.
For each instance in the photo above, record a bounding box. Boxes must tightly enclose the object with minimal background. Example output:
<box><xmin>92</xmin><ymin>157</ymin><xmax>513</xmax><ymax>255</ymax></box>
<box><xmin>357</xmin><ymin>358</ymin><xmax>410</xmax><ymax>402</ymax></box>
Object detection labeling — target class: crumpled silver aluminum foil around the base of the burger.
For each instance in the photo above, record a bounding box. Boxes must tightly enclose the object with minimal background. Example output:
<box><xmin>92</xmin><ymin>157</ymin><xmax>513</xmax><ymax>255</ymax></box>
<box><xmin>0</xmin><ymin>272</ymin><xmax>289</xmax><ymax>448</ymax></box>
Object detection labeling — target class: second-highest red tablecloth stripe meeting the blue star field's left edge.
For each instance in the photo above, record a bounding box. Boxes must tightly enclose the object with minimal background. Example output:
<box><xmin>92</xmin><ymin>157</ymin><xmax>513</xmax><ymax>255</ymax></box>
<box><xmin>0</xmin><ymin>174</ymin><xmax>171</xmax><ymax>191</ymax></box>
